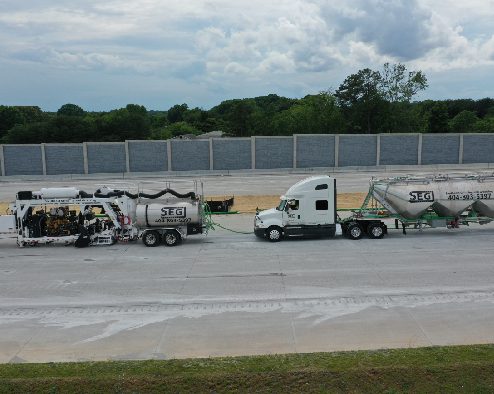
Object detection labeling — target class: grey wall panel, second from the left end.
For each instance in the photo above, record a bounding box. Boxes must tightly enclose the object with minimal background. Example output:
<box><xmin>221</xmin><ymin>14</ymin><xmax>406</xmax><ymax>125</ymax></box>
<box><xmin>45</xmin><ymin>144</ymin><xmax>84</xmax><ymax>175</ymax></box>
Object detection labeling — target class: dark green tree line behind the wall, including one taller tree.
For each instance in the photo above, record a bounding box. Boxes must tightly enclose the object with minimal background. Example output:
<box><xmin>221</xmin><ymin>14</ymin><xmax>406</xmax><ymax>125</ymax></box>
<box><xmin>0</xmin><ymin>63</ymin><xmax>494</xmax><ymax>144</ymax></box>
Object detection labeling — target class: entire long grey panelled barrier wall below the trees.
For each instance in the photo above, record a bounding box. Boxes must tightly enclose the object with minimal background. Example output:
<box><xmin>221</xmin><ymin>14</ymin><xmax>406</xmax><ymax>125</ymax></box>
<box><xmin>0</xmin><ymin>134</ymin><xmax>494</xmax><ymax>176</ymax></box>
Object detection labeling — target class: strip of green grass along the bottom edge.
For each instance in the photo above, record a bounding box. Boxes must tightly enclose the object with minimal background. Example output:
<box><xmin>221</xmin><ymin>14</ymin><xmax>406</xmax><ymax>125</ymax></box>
<box><xmin>0</xmin><ymin>345</ymin><xmax>494</xmax><ymax>393</ymax></box>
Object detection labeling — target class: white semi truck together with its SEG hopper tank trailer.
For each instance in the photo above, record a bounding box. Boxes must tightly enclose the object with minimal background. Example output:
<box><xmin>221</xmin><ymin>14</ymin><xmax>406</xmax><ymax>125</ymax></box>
<box><xmin>254</xmin><ymin>174</ymin><xmax>494</xmax><ymax>242</ymax></box>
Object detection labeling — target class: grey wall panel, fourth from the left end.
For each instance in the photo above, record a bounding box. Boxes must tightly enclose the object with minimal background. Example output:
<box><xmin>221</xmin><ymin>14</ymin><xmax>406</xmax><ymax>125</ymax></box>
<box><xmin>128</xmin><ymin>141</ymin><xmax>168</xmax><ymax>172</ymax></box>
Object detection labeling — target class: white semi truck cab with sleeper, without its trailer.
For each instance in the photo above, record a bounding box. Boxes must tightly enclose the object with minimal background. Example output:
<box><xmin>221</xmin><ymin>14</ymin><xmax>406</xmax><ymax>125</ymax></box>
<box><xmin>254</xmin><ymin>175</ymin><xmax>341</xmax><ymax>242</ymax></box>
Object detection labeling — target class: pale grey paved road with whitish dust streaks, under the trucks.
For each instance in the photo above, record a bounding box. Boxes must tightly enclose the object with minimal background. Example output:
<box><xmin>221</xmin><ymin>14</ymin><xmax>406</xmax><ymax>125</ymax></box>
<box><xmin>0</xmin><ymin>168</ymin><xmax>494</xmax><ymax>362</ymax></box>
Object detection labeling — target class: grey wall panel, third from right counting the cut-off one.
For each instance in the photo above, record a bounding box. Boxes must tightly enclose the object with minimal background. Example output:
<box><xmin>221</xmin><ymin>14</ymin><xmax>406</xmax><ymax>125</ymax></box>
<box><xmin>379</xmin><ymin>134</ymin><xmax>419</xmax><ymax>165</ymax></box>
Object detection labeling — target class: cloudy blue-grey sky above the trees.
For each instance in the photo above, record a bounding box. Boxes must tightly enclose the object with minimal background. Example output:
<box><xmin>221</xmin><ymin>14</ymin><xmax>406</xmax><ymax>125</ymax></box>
<box><xmin>0</xmin><ymin>0</ymin><xmax>494</xmax><ymax>111</ymax></box>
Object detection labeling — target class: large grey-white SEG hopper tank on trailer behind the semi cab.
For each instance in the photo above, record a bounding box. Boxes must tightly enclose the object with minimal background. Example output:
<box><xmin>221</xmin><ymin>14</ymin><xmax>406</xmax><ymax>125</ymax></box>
<box><xmin>371</xmin><ymin>174</ymin><xmax>494</xmax><ymax>219</ymax></box>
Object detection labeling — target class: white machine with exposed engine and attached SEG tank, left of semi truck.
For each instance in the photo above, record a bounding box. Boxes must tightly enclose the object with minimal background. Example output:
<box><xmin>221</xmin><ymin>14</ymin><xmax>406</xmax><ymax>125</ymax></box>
<box><xmin>0</xmin><ymin>182</ymin><xmax>206</xmax><ymax>247</ymax></box>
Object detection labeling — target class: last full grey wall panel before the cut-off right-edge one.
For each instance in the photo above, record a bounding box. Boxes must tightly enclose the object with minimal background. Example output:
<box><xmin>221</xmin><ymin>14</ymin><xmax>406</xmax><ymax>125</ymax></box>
<box><xmin>422</xmin><ymin>134</ymin><xmax>460</xmax><ymax>164</ymax></box>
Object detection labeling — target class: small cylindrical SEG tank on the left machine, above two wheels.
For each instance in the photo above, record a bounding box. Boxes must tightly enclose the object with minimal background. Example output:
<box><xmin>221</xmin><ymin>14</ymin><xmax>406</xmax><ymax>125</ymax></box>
<box><xmin>136</xmin><ymin>202</ymin><xmax>202</xmax><ymax>228</ymax></box>
